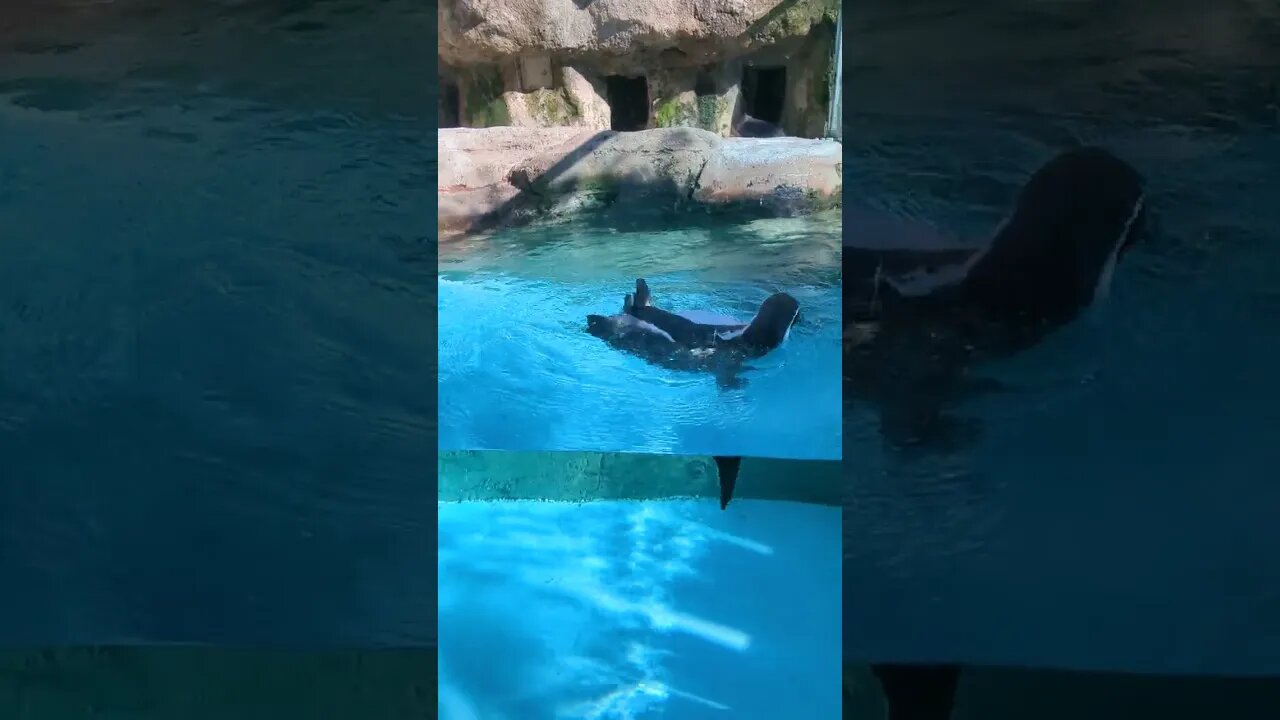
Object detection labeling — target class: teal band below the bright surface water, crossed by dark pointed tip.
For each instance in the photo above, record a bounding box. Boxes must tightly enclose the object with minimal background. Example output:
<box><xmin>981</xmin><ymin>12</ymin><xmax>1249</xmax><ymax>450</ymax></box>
<box><xmin>436</xmin><ymin>450</ymin><xmax>844</xmax><ymax>509</ymax></box>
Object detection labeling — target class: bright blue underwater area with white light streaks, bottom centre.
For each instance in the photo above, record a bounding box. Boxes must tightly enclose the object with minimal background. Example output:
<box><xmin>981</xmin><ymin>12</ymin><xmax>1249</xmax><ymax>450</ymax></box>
<box><xmin>439</xmin><ymin>500</ymin><xmax>841</xmax><ymax>720</ymax></box>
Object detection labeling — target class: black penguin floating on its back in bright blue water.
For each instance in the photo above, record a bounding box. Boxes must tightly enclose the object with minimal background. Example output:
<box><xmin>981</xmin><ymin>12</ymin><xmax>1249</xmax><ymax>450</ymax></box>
<box><xmin>586</xmin><ymin>278</ymin><xmax>800</xmax><ymax>387</ymax></box>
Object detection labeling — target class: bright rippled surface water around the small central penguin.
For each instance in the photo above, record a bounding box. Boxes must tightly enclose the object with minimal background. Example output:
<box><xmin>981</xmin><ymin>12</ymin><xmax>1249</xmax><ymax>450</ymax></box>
<box><xmin>439</xmin><ymin>214</ymin><xmax>841</xmax><ymax>460</ymax></box>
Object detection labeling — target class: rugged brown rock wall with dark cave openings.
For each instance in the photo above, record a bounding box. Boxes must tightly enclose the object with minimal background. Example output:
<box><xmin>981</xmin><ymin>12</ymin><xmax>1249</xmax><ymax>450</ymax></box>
<box><xmin>438</xmin><ymin>0</ymin><xmax>838</xmax><ymax>137</ymax></box>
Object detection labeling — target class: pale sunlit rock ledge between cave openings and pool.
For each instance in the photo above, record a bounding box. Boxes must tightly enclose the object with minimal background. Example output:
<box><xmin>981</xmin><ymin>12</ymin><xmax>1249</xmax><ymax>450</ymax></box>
<box><xmin>436</xmin><ymin>127</ymin><xmax>842</xmax><ymax>240</ymax></box>
